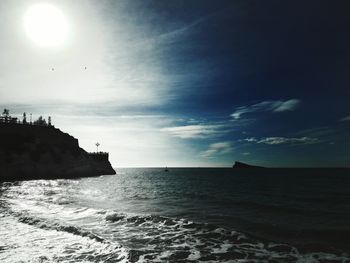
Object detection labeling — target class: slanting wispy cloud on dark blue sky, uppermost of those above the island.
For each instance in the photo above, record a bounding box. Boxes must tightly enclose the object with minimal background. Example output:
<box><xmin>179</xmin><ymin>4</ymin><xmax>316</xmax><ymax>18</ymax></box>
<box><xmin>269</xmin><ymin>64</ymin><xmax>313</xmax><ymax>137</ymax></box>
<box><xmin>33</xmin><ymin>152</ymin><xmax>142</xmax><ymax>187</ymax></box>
<box><xmin>231</xmin><ymin>99</ymin><xmax>300</xmax><ymax>119</ymax></box>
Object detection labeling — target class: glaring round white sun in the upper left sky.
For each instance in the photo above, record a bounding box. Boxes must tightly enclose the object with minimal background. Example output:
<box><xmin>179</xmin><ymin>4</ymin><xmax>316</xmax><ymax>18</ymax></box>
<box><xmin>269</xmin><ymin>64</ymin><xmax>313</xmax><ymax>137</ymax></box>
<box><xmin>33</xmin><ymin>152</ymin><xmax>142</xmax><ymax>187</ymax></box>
<box><xmin>23</xmin><ymin>3</ymin><xmax>68</xmax><ymax>47</ymax></box>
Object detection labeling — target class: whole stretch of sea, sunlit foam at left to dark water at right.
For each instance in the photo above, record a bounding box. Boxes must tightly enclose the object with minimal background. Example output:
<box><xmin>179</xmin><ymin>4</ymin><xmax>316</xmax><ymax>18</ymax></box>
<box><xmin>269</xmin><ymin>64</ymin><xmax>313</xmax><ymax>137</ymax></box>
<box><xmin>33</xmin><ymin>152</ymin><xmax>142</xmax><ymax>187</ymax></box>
<box><xmin>0</xmin><ymin>168</ymin><xmax>350</xmax><ymax>263</ymax></box>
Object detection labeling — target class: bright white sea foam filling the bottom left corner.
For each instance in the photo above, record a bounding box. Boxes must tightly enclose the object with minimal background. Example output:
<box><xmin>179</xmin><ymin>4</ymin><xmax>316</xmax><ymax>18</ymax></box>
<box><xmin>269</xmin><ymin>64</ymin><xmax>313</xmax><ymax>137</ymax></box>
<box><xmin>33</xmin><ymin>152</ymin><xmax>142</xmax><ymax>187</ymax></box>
<box><xmin>0</xmin><ymin>216</ymin><xmax>128</xmax><ymax>263</ymax></box>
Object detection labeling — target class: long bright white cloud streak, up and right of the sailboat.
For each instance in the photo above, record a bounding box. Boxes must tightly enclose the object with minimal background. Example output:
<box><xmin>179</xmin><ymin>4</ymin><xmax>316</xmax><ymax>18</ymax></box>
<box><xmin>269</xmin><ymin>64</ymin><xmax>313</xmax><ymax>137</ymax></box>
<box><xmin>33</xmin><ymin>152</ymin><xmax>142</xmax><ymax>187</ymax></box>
<box><xmin>161</xmin><ymin>124</ymin><xmax>225</xmax><ymax>139</ymax></box>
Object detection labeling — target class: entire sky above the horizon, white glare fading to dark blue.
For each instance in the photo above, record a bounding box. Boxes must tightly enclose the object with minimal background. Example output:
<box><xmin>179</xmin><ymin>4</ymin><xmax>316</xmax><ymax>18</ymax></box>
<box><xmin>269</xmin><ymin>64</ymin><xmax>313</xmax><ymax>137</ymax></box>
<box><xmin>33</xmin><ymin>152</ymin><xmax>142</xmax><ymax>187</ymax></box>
<box><xmin>0</xmin><ymin>0</ymin><xmax>350</xmax><ymax>167</ymax></box>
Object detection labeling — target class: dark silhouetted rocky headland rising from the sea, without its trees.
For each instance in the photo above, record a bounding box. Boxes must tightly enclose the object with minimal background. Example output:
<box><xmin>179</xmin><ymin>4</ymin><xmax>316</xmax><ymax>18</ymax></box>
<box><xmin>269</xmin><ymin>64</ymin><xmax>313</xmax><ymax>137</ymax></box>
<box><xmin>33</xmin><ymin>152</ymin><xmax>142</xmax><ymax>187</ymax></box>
<box><xmin>0</xmin><ymin>123</ymin><xmax>115</xmax><ymax>181</ymax></box>
